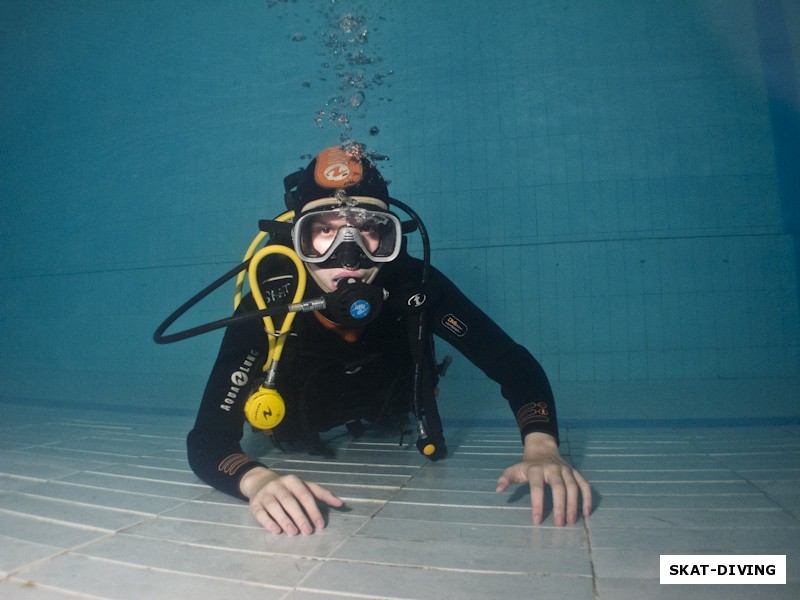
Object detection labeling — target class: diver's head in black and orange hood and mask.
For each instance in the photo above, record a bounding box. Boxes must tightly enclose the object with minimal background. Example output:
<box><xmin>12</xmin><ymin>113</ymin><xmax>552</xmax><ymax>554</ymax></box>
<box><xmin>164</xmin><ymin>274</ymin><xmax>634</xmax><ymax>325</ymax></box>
<box><xmin>286</xmin><ymin>144</ymin><xmax>402</xmax><ymax>292</ymax></box>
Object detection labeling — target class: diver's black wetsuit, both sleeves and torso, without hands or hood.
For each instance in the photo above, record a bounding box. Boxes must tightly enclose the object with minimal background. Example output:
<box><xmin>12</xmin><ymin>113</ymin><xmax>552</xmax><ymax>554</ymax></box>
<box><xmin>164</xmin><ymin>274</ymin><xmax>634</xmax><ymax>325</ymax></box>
<box><xmin>188</xmin><ymin>253</ymin><xmax>558</xmax><ymax>498</ymax></box>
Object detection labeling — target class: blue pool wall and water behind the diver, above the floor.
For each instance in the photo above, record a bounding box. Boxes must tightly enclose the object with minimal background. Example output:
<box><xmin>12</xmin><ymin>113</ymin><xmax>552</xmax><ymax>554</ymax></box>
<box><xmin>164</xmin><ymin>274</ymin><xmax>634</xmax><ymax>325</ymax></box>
<box><xmin>0</xmin><ymin>0</ymin><xmax>800</xmax><ymax>424</ymax></box>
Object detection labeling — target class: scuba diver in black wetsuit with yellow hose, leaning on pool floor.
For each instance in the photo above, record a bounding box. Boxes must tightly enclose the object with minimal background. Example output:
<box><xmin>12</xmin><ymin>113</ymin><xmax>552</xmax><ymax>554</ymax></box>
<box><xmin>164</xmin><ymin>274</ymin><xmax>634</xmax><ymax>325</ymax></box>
<box><xmin>155</xmin><ymin>143</ymin><xmax>592</xmax><ymax>535</ymax></box>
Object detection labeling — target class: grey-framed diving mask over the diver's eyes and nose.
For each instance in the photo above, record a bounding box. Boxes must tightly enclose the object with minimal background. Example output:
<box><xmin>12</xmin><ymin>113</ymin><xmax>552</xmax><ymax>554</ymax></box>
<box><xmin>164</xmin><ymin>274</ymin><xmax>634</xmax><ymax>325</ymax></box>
<box><xmin>292</xmin><ymin>197</ymin><xmax>403</xmax><ymax>266</ymax></box>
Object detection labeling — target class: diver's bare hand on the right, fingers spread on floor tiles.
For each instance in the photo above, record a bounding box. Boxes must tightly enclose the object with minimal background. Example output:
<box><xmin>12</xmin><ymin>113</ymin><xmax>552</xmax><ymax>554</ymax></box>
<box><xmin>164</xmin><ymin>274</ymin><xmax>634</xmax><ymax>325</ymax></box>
<box><xmin>497</xmin><ymin>432</ymin><xmax>592</xmax><ymax>527</ymax></box>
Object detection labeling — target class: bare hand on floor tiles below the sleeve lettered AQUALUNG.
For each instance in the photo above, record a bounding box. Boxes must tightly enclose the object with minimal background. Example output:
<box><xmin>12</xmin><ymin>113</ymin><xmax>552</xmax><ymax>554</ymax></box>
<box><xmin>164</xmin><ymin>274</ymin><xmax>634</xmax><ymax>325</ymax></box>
<box><xmin>234</xmin><ymin>467</ymin><xmax>344</xmax><ymax>535</ymax></box>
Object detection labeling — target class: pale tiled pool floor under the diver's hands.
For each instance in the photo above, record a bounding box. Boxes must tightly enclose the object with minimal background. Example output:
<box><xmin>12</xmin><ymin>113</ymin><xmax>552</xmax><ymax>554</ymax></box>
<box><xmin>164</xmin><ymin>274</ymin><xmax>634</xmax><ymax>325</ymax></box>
<box><xmin>0</xmin><ymin>403</ymin><xmax>800</xmax><ymax>600</ymax></box>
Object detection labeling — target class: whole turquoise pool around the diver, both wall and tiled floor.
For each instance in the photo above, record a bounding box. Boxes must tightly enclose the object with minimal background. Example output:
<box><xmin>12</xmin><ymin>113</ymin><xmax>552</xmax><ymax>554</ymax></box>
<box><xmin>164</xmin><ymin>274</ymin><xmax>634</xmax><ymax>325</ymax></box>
<box><xmin>0</xmin><ymin>0</ymin><xmax>800</xmax><ymax>600</ymax></box>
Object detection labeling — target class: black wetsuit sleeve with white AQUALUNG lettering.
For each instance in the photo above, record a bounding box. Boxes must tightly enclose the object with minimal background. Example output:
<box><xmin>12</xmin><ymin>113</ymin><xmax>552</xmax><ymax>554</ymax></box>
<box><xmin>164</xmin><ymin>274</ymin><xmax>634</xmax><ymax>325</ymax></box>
<box><xmin>187</xmin><ymin>296</ymin><xmax>267</xmax><ymax>499</ymax></box>
